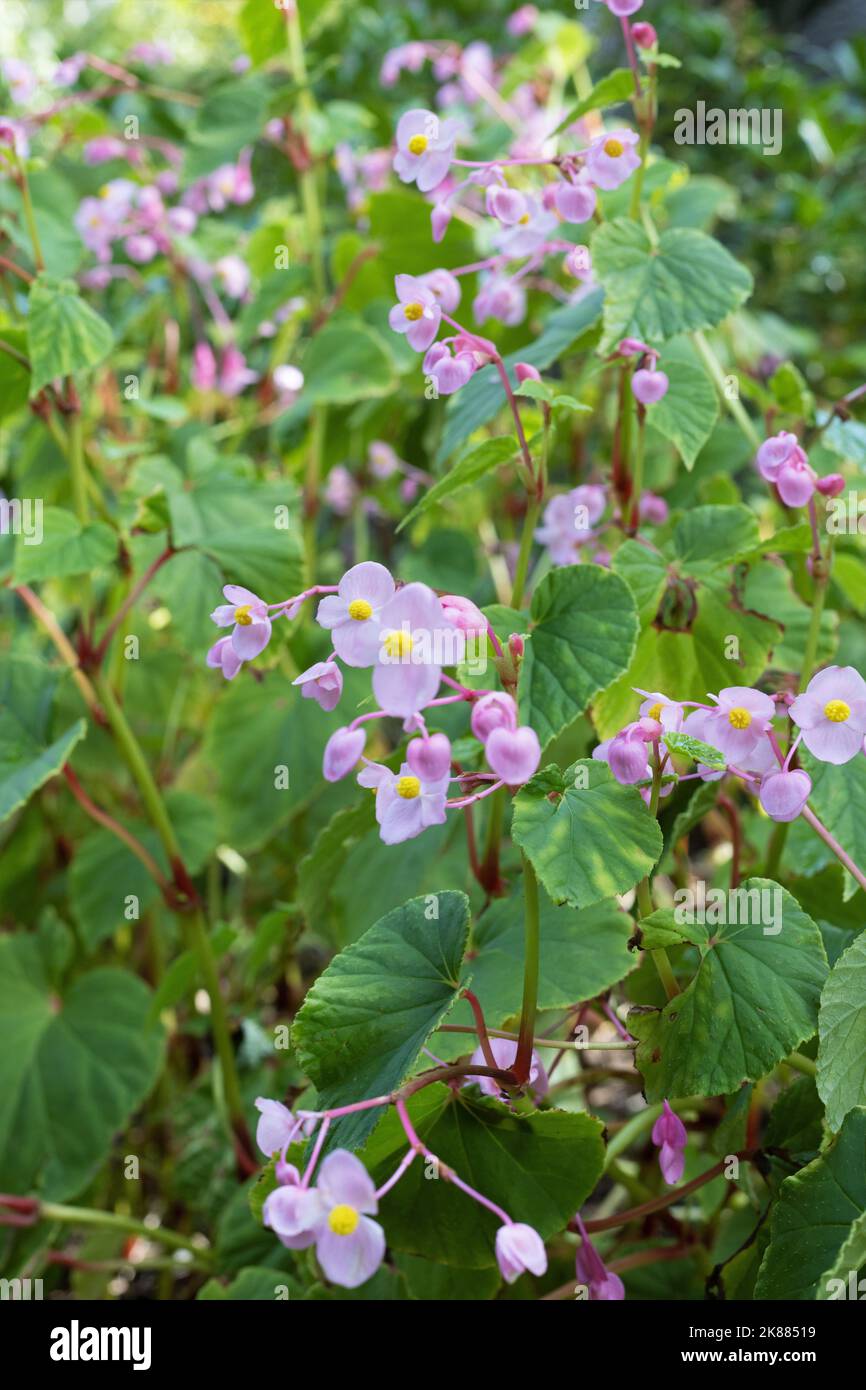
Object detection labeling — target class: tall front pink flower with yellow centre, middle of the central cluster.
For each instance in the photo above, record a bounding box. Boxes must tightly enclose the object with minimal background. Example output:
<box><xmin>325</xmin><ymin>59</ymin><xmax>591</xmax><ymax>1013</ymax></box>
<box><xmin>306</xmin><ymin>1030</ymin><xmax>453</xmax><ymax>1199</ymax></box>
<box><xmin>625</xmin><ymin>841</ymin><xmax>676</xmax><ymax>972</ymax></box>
<box><xmin>373</xmin><ymin>584</ymin><xmax>453</xmax><ymax>719</ymax></box>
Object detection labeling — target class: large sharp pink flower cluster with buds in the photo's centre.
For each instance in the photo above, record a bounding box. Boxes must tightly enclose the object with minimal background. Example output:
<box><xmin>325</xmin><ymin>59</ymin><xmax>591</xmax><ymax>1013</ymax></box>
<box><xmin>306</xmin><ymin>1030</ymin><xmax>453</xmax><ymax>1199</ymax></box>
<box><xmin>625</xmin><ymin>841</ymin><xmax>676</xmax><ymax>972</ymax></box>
<box><xmin>207</xmin><ymin>560</ymin><xmax>541</xmax><ymax>845</ymax></box>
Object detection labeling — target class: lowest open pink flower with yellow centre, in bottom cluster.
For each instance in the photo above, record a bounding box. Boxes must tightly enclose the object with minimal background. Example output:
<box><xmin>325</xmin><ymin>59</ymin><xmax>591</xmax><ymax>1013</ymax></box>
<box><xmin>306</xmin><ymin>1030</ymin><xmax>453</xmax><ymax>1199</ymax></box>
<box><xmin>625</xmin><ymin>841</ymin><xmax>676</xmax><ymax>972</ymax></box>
<box><xmin>309</xmin><ymin>1148</ymin><xmax>385</xmax><ymax>1289</ymax></box>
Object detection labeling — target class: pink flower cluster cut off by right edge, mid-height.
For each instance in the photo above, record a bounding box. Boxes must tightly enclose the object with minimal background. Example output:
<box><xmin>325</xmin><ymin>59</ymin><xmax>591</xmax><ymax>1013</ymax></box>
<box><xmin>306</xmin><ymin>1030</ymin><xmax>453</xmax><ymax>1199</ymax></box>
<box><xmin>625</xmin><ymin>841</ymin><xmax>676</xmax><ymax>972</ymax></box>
<box><xmin>592</xmin><ymin>666</ymin><xmax>866</xmax><ymax>821</ymax></box>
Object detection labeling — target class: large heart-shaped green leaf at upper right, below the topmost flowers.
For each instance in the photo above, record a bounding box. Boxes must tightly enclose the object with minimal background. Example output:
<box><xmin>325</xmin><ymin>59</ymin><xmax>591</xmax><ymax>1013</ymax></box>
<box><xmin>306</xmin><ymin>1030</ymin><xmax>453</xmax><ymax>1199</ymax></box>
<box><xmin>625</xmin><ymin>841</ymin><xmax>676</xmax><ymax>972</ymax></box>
<box><xmin>591</xmin><ymin>217</ymin><xmax>752</xmax><ymax>353</ymax></box>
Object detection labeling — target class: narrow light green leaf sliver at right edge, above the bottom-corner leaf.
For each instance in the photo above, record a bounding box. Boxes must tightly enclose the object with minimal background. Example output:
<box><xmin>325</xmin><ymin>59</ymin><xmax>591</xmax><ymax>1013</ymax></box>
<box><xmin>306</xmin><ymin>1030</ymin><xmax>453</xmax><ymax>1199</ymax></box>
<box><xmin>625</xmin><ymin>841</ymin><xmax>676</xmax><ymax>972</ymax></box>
<box><xmin>817</xmin><ymin>933</ymin><xmax>866</xmax><ymax>1130</ymax></box>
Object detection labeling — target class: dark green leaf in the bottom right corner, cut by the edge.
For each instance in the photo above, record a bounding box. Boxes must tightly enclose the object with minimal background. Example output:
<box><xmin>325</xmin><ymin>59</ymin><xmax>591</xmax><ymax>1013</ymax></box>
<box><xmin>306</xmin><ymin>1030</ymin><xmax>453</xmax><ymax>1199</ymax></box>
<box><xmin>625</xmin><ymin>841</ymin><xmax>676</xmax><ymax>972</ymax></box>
<box><xmin>755</xmin><ymin>1109</ymin><xmax>866</xmax><ymax>1300</ymax></box>
